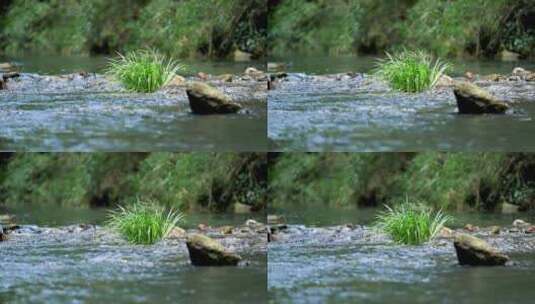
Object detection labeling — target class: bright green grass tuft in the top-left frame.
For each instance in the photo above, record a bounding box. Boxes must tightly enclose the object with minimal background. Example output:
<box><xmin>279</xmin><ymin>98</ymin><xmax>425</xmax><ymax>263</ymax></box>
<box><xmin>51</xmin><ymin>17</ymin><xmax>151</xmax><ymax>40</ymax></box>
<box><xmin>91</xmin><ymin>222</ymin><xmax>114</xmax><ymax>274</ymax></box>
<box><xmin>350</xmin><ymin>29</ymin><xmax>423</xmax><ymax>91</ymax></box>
<box><xmin>108</xmin><ymin>50</ymin><xmax>183</xmax><ymax>93</ymax></box>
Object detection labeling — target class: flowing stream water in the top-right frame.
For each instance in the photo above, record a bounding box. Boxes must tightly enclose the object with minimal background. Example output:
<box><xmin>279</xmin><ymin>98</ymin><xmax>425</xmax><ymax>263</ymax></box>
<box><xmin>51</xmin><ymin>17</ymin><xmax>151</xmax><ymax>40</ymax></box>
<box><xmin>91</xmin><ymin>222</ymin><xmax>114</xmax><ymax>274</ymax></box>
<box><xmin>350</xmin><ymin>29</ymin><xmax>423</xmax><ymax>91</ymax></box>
<box><xmin>268</xmin><ymin>57</ymin><xmax>535</xmax><ymax>152</ymax></box>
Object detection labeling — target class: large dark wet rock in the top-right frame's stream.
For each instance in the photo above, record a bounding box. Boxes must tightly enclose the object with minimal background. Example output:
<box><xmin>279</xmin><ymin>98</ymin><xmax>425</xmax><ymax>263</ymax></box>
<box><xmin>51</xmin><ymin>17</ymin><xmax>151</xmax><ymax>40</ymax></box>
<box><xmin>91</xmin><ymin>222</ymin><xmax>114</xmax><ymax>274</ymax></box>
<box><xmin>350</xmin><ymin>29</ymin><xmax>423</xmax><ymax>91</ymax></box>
<box><xmin>453</xmin><ymin>82</ymin><xmax>509</xmax><ymax>114</ymax></box>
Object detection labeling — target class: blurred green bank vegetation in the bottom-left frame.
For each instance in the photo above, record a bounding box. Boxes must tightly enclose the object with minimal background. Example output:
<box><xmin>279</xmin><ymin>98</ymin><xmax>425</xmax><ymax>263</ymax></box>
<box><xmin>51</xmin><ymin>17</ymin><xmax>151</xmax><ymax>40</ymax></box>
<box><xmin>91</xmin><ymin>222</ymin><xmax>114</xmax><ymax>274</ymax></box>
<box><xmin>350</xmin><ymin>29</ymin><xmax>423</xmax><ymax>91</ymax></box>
<box><xmin>0</xmin><ymin>153</ymin><xmax>267</xmax><ymax>212</ymax></box>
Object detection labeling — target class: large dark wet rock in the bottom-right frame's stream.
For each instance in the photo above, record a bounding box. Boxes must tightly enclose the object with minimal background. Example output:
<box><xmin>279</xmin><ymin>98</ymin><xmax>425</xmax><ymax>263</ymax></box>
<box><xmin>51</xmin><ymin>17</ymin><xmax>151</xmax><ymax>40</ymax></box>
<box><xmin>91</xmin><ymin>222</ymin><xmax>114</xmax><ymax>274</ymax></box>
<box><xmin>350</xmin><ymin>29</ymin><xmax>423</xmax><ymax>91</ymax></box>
<box><xmin>453</xmin><ymin>234</ymin><xmax>509</xmax><ymax>266</ymax></box>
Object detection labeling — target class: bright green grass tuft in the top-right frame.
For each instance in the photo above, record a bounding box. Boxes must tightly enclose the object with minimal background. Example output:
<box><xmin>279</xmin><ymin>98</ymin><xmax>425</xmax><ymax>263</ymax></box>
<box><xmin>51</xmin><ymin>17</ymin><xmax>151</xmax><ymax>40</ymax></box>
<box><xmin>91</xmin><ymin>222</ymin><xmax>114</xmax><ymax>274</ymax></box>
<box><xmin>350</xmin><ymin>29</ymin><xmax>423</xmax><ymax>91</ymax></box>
<box><xmin>375</xmin><ymin>50</ymin><xmax>449</xmax><ymax>93</ymax></box>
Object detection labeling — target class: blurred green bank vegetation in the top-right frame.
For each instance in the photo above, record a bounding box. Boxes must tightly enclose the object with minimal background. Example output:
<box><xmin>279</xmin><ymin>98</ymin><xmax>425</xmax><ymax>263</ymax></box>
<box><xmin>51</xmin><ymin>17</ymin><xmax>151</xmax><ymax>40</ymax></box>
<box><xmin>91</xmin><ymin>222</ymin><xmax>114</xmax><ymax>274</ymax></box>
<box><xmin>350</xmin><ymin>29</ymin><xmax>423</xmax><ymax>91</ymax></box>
<box><xmin>268</xmin><ymin>0</ymin><xmax>535</xmax><ymax>57</ymax></box>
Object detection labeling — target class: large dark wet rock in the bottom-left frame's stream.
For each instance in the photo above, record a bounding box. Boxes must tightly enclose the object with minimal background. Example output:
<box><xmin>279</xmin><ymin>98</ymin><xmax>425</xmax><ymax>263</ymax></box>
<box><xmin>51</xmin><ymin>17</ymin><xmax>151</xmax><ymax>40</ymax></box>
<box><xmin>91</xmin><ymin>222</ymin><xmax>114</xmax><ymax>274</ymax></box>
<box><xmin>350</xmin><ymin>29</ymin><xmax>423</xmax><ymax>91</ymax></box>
<box><xmin>186</xmin><ymin>234</ymin><xmax>241</xmax><ymax>266</ymax></box>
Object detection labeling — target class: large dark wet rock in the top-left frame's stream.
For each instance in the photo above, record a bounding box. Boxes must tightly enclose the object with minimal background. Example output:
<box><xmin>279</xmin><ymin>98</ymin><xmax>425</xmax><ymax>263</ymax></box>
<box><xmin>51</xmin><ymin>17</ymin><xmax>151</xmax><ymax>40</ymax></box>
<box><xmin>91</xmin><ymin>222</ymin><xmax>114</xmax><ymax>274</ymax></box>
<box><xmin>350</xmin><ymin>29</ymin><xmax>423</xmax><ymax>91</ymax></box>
<box><xmin>186</xmin><ymin>82</ymin><xmax>241</xmax><ymax>114</ymax></box>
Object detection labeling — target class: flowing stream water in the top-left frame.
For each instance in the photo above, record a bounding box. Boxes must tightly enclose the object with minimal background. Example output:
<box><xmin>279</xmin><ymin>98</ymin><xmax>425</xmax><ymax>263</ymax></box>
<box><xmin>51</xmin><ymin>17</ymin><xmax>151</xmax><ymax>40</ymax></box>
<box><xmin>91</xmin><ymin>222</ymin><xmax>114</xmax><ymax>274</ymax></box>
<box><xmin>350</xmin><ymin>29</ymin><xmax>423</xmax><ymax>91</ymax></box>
<box><xmin>0</xmin><ymin>57</ymin><xmax>268</xmax><ymax>151</ymax></box>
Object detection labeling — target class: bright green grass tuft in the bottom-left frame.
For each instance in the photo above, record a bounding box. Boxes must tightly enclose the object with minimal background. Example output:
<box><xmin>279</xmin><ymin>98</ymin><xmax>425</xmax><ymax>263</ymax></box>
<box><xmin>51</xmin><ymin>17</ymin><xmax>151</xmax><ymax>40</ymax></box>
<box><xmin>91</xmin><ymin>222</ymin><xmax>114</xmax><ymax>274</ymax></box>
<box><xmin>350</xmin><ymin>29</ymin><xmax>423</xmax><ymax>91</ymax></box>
<box><xmin>108</xmin><ymin>202</ymin><xmax>184</xmax><ymax>245</ymax></box>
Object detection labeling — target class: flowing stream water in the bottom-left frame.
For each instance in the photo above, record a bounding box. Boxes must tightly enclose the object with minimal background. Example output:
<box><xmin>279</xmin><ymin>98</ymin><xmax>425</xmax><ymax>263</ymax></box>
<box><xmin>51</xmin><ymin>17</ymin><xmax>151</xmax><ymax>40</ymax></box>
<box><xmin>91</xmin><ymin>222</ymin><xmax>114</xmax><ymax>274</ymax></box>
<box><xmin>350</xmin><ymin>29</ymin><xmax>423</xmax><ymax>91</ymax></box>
<box><xmin>0</xmin><ymin>205</ymin><xmax>267</xmax><ymax>303</ymax></box>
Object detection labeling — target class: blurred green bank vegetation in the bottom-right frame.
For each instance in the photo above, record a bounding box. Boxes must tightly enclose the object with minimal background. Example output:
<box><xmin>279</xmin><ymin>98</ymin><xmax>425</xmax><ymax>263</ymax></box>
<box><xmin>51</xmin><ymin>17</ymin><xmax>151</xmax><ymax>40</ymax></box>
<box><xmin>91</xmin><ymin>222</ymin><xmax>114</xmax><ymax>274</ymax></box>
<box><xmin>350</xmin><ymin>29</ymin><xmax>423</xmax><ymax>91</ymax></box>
<box><xmin>269</xmin><ymin>152</ymin><xmax>535</xmax><ymax>211</ymax></box>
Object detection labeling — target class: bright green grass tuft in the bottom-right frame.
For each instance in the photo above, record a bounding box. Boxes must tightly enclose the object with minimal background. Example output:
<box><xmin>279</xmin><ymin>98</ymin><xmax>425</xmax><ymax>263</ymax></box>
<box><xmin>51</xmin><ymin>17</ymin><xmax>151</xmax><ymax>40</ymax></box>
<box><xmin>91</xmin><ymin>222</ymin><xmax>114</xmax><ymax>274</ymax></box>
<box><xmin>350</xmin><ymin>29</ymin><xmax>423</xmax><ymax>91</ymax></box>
<box><xmin>376</xmin><ymin>199</ymin><xmax>452</xmax><ymax>245</ymax></box>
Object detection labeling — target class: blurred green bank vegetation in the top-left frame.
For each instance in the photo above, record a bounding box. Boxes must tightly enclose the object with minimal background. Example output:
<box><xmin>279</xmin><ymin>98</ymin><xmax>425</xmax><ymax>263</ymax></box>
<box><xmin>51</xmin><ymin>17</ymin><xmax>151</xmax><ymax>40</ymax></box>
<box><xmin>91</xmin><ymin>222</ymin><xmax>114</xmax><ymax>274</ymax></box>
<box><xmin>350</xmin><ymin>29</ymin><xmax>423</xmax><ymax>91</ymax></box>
<box><xmin>0</xmin><ymin>0</ymin><xmax>267</xmax><ymax>57</ymax></box>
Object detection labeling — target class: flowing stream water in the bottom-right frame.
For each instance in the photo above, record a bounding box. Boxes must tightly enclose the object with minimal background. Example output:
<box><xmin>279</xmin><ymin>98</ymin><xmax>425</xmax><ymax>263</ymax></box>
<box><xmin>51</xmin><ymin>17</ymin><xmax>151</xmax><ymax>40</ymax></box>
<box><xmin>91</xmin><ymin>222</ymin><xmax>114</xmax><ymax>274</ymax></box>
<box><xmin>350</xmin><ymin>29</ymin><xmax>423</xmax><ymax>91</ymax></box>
<box><xmin>268</xmin><ymin>208</ymin><xmax>535</xmax><ymax>303</ymax></box>
